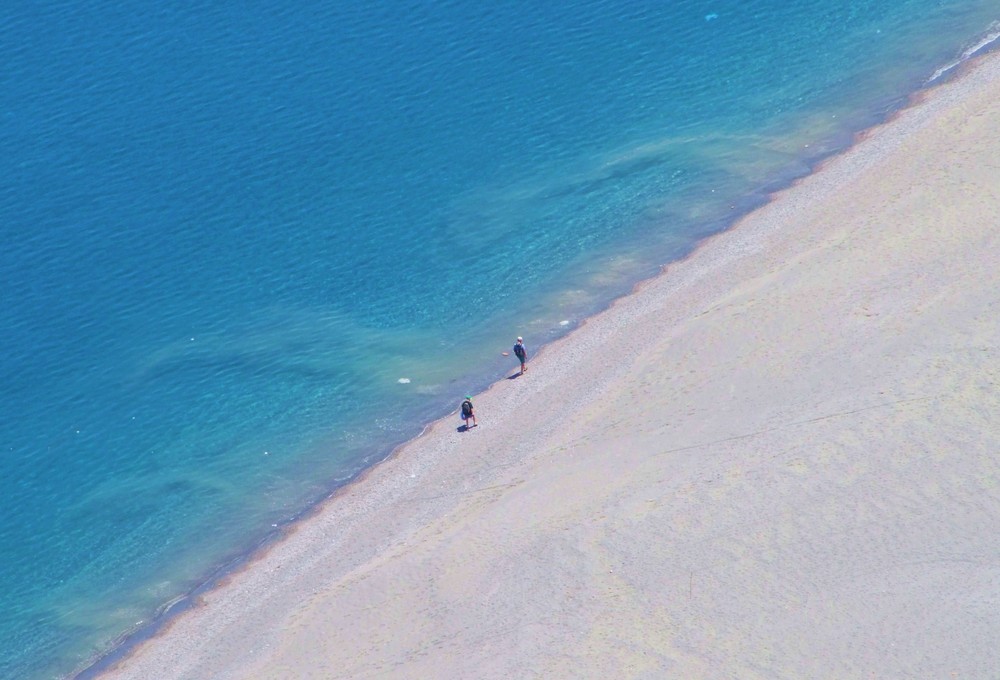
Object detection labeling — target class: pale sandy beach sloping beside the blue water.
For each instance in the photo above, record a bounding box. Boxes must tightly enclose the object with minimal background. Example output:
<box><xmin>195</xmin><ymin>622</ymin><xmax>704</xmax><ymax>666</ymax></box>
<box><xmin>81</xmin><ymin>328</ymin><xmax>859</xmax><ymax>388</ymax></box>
<box><xmin>99</xmin><ymin>56</ymin><xmax>1000</xmax><ymax>679</ymax></box>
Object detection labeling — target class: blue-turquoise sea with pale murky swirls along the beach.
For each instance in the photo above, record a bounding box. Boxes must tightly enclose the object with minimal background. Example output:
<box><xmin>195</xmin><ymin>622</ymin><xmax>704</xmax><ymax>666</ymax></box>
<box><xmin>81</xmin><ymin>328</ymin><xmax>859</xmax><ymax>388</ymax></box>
<box><xmin>0</xmin><ymin>0</ymin><xmax>1000</xmax><ymax>678</ymax></box>
